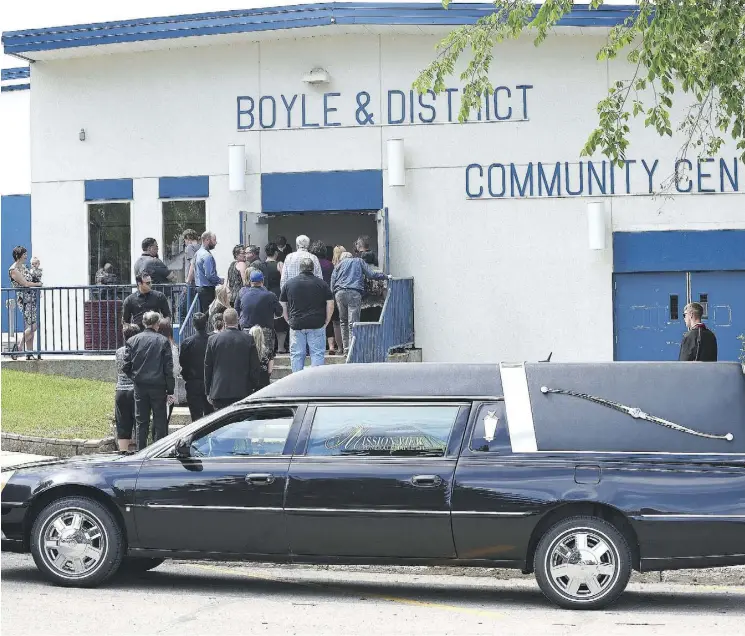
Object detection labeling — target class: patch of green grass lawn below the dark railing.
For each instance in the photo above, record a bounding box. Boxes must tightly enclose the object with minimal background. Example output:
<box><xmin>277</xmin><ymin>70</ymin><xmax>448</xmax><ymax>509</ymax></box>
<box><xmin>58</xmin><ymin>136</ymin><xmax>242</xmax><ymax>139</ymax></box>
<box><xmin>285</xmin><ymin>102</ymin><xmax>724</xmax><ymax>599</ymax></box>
<box><xmin>0</xmin><ymin>366</ymin><xmax>114</xmax><ymax>439</ymax></box>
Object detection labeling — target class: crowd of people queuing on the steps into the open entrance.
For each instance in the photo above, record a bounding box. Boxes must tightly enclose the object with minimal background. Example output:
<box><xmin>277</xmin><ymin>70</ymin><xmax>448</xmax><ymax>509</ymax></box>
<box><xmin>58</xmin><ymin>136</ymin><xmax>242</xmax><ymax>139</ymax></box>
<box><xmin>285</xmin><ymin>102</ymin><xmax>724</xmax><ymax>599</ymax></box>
<box><xmin>115</xmin><ymin>230</ymin><xmax>388</xmax><ymax>450</ymax></box>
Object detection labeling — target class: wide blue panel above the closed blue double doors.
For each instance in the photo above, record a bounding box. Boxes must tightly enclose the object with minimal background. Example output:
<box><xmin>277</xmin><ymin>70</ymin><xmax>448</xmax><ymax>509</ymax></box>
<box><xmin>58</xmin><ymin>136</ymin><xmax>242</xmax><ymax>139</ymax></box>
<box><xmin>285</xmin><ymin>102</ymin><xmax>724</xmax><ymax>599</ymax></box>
<box><xmin>613</xmin><ymin>230</ymin><xmax>745</xmax><ymax>274</ymax></box>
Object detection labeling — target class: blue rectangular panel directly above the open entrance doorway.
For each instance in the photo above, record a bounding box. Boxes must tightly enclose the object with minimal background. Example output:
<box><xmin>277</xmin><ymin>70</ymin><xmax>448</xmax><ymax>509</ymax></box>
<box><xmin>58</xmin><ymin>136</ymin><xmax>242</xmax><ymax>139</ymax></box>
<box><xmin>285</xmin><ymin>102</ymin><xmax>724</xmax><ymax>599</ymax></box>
<box><xmin>261</xmin><ymin>170</ymin><xmax>383</xmax><ymax>214</ymax></box>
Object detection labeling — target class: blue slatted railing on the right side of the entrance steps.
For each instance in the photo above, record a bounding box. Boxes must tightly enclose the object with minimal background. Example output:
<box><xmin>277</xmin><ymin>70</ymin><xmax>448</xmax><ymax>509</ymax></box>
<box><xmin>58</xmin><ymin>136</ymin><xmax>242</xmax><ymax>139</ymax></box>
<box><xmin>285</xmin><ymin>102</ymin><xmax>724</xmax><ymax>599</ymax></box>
<box><xmin>347</xmin><ymin>278</ymin><xmax>414</xmax><ymax>363</ymax></box>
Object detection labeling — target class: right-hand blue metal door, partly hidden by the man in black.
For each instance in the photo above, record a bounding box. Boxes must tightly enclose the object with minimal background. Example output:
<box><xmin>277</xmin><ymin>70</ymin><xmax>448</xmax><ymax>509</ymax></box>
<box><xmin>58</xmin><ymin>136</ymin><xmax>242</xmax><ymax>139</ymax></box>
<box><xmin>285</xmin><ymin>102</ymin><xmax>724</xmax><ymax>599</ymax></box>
<box><xmin>690</xmin><ymin>272</ymin><xmax>745</xmax><ymax>360</ymax></box>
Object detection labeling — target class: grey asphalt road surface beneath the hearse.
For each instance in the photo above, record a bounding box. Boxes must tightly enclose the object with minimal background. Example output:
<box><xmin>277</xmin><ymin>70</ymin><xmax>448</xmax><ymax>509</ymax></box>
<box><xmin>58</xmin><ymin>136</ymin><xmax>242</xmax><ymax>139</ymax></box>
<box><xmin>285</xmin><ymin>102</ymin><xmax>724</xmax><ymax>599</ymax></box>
<box><xmin>0</xmin><ymin>553</ymin><xmax>745</xmax><ymax>636</ymax></box>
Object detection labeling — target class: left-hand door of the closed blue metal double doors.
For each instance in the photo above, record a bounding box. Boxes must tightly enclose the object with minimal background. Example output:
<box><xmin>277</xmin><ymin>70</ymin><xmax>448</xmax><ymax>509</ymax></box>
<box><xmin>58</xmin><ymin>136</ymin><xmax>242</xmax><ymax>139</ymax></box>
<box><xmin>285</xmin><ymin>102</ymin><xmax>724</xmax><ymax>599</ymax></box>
<box><xmin>614</xmin><ymin>272</ymin><xmax>687</xmax><ymax>361</ymax></box>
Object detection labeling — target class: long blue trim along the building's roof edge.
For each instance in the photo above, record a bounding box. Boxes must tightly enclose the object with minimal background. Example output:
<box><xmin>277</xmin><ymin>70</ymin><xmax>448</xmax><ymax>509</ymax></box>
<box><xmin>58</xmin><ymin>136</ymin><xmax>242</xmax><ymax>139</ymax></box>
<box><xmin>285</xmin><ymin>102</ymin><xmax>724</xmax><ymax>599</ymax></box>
<box><xmin>2</xmin><ymin>2</ymin><xmax>637</xmax><ymax>54</ymax></box>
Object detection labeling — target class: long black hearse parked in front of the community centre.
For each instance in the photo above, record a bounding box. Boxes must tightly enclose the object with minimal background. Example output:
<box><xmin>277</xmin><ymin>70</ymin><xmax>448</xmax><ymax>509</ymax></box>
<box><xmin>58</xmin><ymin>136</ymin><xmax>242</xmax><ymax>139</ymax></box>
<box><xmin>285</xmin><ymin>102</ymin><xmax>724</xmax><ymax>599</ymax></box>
<box><xmin>2</xmin><ymin>363</ymin><xmax>745</xmax><ymax>609</ymax></box>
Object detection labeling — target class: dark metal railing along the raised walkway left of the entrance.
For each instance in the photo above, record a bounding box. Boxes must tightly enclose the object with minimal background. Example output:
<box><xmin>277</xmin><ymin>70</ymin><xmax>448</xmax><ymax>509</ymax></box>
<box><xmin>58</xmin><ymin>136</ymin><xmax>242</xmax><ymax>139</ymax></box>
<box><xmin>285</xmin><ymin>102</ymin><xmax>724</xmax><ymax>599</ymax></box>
<box><xmin>0</xmin><ymin>283</ymin><xmax>195</xmax><ymax>356</ymax></box>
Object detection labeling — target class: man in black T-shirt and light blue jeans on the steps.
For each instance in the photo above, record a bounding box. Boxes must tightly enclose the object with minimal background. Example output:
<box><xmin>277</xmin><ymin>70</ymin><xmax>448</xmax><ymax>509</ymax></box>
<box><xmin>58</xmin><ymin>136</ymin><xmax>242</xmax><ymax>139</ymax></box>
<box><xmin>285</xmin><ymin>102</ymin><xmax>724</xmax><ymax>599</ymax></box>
<box><xmin>279</xmin><ymin>252</ymin><xmax>334</xmax><ymax>373</ymax></box>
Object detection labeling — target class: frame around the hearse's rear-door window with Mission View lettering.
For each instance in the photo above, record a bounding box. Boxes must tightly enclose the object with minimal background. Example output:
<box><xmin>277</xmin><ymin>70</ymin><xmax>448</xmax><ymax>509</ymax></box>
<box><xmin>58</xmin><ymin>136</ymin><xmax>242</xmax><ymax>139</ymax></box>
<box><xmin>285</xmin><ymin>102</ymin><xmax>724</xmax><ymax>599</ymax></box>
<box><xmin>293</xmin><ymin>398</ymin><xmax>471</xmax><ymax>462</ymax></box>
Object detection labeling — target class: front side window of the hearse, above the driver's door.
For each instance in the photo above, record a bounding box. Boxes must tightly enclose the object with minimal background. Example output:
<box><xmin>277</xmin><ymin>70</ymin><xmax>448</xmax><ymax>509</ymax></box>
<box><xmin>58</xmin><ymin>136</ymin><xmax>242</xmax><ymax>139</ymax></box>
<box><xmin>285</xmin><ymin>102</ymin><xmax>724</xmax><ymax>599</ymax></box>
<box><xmin>191</xmin><ymin>409</ymin><xmax>294</xmax><ymax>457</ymax></box>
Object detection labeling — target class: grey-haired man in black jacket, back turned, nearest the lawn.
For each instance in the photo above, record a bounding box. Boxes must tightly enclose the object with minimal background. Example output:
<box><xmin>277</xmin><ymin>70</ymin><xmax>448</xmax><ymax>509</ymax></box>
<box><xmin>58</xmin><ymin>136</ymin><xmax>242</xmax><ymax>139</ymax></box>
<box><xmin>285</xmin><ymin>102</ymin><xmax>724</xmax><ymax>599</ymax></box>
<box><xmin>122</xmin><ymin>311</ymin><xmax>175</xmax><ymax>450</ymax></box>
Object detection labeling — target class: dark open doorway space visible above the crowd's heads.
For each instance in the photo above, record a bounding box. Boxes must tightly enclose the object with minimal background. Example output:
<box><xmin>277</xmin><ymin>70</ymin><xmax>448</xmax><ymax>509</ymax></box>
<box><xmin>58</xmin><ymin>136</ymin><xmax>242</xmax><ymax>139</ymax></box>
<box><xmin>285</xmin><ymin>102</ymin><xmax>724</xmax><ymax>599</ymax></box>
<box><xmin>262</xmin><ymin>210</ymin><xmax>380</xmax><ymax>256</ymax></box>
